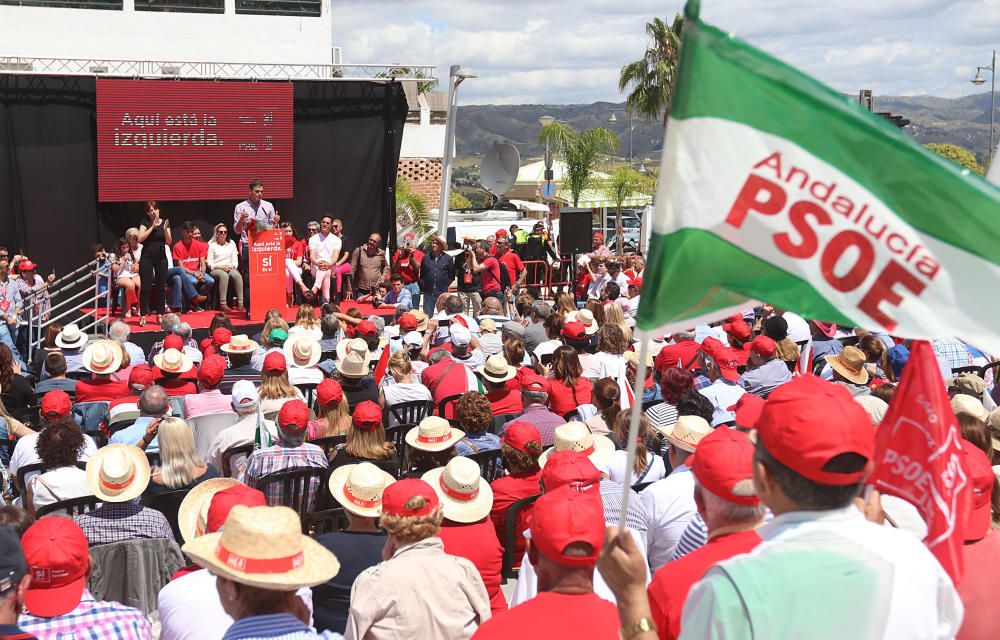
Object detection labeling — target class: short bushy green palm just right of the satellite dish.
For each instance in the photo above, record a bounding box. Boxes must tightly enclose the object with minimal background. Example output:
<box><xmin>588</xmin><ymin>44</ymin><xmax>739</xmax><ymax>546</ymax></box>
<box><xmin>538</xmin><ymin>122</ymin><xmax>618</xmax><ymax>207</ymax></box>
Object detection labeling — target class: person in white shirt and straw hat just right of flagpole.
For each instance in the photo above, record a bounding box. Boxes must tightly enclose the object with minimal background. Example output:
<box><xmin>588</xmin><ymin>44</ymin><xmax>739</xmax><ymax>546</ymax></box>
<box><xmin>639</xmin><ymin>416</ymin><xmax>712</xmax><ymax>573</ymax></box>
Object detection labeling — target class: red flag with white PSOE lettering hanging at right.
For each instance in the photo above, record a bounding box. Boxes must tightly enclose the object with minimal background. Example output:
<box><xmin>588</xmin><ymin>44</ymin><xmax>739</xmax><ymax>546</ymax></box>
<box><xmin>869</xmin><ymin>341</ymin><xmax>971</xmax><ymax>584</ymax></box>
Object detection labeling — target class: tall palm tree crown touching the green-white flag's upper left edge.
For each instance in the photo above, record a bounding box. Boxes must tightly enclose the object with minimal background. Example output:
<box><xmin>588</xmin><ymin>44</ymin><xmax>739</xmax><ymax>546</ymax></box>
<box><xmin>618</xmin><ymin>13</ymin><xmax>684</xmax><ymax>126</ymax></box>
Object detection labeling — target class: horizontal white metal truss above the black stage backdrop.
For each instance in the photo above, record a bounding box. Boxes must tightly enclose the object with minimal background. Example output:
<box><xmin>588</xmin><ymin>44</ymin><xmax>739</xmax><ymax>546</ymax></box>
<box><xmin>0</xmin><ymin>56</ymin><xmax>435</xmax><ymax>82</ymax></box>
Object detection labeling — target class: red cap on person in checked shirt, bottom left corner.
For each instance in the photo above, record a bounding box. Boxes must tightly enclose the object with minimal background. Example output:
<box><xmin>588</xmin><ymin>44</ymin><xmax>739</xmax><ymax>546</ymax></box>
<box><xmin>21</xmin><ymin>517</ymin><xmax>90</xmax><ymax>618</ymax></box>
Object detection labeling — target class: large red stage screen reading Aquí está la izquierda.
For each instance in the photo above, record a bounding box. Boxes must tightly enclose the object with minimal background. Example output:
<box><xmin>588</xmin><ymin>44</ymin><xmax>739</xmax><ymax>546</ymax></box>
<box><xmin>97</xmin><ymin>78</ymin><xmax>293</xmax><ymax>202</ymax></box>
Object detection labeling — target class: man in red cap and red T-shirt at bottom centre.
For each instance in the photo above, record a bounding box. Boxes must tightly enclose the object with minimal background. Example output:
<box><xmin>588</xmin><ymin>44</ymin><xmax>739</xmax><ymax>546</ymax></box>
<box><xmin>472</xmin><ymin>485</ymin><xmax>621</xmax><ymax>640</ymax></box>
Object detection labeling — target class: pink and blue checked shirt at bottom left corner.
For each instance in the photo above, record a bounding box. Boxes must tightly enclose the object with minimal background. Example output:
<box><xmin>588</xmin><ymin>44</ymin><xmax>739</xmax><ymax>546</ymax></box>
<box><xmin>17</xmin><ymin>589</ymin><xmax>153</xmax><ymax>640</ymax></box>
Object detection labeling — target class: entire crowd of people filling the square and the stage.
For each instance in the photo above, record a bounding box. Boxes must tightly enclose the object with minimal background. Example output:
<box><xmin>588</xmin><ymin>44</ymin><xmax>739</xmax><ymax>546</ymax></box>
<box><xmin>0</xmin><ymin>194</ymin><xmax>1000</xmax><ymax>640</ymax></box>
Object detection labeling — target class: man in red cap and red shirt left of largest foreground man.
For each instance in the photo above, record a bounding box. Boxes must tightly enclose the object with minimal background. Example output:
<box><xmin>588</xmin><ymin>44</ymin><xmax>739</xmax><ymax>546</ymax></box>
<box><xmin>648</xmin><ymin>427</ymin><xmax>764</xmax><ymax>639</ymax></box>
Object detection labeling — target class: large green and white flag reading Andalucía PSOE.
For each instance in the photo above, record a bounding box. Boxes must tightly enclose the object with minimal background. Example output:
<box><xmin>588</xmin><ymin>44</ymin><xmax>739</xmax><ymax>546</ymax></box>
<box><xmin>637</xmin><ymin>0</ymin><xmax>1000</xmax><ymax>353</ymax></box>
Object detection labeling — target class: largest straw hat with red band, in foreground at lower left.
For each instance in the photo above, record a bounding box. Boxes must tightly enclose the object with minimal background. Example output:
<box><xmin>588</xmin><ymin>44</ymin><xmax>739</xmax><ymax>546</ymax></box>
<box><xmin>183</xmin><ymin>505</ymin><xmax>340</xmax><ymax>591</ymax></box>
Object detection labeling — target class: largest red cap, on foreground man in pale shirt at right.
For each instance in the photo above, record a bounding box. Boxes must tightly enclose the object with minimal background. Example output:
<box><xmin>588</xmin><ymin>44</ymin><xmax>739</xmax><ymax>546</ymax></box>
<box><xmin>756</xmin><ymin>375</ymin><xmax>875</xmax><ymax>486</ymax></box>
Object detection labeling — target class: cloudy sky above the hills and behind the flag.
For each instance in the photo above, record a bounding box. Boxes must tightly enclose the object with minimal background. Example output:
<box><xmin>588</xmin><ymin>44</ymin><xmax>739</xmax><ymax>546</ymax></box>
<box><xmin>331</xmin><ymin>0</ymin><xmax>1000</xmax><ymax>104</ymax></box>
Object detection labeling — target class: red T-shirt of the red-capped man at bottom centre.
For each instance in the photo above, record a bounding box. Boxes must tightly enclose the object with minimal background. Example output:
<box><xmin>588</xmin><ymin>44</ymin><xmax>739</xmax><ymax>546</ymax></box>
<box><xmin>472</xmin><ymin>592</ymin><xmax>621</xmax><ymax>640</ymax></box>
